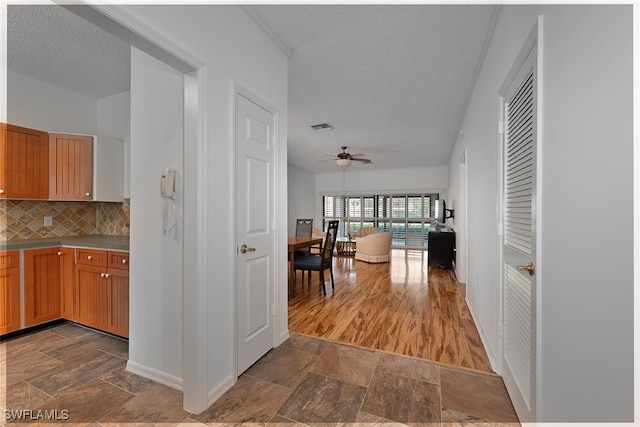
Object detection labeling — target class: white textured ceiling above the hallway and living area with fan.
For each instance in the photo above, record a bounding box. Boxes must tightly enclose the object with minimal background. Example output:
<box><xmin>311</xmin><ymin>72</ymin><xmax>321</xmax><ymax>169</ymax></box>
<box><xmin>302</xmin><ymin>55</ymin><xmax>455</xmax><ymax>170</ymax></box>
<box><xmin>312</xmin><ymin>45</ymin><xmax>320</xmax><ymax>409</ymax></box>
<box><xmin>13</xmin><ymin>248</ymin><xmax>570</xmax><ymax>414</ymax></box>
<box><xmin>251</xmin><ymin>5</ymin><xmax>495</xmax><ymax>172</ymax></box>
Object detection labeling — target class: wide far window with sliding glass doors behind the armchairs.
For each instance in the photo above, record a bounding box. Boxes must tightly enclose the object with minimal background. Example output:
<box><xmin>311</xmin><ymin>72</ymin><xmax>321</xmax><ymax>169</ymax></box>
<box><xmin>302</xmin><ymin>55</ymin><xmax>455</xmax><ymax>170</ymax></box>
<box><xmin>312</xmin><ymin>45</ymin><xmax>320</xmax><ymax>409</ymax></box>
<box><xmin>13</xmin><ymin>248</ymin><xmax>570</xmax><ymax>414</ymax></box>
<box><xmin>322</xmin><ymin>194</ymin><xmax>438</xmax><ymax>248</ymax></box>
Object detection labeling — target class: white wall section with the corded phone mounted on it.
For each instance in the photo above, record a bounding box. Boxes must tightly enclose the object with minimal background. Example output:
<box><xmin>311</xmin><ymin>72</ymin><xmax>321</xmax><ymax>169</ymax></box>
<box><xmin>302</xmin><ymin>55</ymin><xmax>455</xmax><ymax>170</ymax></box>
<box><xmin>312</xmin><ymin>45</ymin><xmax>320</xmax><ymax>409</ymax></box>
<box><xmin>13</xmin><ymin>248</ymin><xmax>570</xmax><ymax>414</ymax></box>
<box><xmin>128</xmin><ymin>48</ymin><xmax>184</xmax><ymax>387</ymax></box>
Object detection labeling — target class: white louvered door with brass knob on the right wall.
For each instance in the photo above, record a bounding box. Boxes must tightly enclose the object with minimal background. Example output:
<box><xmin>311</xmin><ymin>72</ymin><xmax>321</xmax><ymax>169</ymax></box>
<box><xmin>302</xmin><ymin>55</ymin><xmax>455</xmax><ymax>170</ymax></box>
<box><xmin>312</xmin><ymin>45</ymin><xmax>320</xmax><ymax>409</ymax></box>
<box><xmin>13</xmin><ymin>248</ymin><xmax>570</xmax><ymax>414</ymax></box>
<box><xmin>501</xmin><ymin>29</ymin><xmax>538</xmax><ymax>422</ymax></box>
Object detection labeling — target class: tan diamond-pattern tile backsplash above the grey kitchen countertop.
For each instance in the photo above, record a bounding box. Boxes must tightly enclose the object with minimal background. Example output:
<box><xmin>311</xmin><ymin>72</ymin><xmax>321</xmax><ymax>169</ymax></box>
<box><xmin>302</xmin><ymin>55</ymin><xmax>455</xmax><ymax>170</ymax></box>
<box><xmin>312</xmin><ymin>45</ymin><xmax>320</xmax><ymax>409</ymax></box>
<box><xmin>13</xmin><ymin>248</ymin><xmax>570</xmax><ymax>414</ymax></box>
<box><xmin>0</xmin><ymin>199</ymin><xmax>130</xmax><ymax>240</ymax></box>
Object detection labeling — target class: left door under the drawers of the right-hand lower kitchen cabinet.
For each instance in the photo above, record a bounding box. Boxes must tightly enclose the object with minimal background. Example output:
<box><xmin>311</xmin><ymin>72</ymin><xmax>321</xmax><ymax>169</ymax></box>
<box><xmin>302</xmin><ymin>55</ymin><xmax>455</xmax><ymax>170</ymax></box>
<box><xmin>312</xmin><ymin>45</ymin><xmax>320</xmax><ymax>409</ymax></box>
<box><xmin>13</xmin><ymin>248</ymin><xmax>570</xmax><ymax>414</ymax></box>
<box><xmin>75</xmin><ymin>264</ymin><xmax>109</xmax><ymax>330</ymax></box>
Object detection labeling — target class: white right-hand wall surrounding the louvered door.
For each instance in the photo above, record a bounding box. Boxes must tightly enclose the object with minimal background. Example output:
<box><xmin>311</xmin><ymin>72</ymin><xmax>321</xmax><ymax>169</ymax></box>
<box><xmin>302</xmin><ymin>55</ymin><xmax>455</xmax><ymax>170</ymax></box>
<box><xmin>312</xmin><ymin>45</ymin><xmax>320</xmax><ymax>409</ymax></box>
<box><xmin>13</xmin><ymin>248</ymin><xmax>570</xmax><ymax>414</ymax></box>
<box><xmin>449</xmin><ymin>5</ymin><xmax>634</xmax><ymax>422</ymax></box>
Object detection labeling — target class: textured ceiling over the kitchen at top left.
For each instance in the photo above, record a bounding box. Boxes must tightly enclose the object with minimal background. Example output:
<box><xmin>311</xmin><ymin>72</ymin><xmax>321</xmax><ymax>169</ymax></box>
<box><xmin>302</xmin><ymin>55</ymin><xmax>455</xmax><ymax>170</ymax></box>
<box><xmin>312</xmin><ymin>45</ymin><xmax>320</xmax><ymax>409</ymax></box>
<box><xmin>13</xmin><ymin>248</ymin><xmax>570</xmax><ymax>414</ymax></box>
<box><xmin>7</xmin><ymin>5</ymin><xmax>131</xmax><ymax>99</ymax></box>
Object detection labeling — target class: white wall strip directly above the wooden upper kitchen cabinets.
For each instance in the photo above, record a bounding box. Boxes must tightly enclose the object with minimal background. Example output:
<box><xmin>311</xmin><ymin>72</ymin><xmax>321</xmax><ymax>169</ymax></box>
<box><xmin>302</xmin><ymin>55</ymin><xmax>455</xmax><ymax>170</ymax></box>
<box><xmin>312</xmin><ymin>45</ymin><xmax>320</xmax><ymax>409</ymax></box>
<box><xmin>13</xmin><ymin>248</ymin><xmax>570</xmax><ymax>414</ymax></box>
<box><xmin>7</xmin><ymin>70</ymin><xmax>98</xmax><ymax>135</ymax></box>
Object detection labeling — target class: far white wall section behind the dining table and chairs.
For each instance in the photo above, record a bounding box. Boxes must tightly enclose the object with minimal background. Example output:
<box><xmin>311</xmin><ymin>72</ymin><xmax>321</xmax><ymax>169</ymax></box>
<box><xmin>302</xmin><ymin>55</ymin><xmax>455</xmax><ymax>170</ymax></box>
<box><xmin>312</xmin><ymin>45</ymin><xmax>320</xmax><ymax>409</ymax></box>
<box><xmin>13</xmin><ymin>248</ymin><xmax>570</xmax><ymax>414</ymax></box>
<box><xmin>287</xmin><ymin>166</ymin><xmax>322</xmax><ymax>236</ymax></box>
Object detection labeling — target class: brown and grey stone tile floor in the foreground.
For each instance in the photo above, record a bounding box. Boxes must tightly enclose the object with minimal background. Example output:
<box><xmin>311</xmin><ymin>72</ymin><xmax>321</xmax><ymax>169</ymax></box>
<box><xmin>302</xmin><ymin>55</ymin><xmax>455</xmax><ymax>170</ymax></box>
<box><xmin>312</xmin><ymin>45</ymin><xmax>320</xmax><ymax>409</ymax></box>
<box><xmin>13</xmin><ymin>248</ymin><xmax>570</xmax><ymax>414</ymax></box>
<box><xmin>0</xmin><ymin>323</ymin><xmax>519</xmax><ymax>426</ymax></box>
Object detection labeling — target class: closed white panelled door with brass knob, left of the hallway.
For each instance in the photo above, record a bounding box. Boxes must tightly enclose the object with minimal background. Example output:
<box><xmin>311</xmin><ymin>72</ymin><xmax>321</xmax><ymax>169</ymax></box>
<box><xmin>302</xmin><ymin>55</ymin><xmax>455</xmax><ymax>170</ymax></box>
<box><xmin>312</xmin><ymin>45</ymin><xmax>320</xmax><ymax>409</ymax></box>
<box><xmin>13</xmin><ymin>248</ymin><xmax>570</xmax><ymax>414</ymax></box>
<box><xmin>236</xmin><ymin>94</ymin><xmax>275</xmax><ymax>375</ymax></box>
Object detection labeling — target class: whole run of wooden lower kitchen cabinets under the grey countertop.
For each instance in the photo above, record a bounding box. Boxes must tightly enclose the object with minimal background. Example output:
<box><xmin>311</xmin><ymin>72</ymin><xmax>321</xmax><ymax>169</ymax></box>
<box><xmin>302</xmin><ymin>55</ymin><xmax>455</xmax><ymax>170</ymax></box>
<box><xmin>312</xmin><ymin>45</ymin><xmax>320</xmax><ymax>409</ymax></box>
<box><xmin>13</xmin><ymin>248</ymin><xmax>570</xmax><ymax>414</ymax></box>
<box><xmin>0</xmin><ymin>247</ymin><xmax>129</xmax><ymax>338</ymax></box>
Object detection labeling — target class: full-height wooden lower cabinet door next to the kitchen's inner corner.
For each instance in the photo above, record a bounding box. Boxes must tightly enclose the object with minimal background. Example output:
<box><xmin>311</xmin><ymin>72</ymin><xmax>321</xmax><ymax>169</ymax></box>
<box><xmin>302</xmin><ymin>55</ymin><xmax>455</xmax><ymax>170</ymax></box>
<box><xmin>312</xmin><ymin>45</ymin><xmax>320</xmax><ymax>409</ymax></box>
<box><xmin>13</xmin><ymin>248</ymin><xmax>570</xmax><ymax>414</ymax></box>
<box><xmin>24</xmin><ymin>248</ymin><xmax>60</xmax><ymax>326</ymax></box>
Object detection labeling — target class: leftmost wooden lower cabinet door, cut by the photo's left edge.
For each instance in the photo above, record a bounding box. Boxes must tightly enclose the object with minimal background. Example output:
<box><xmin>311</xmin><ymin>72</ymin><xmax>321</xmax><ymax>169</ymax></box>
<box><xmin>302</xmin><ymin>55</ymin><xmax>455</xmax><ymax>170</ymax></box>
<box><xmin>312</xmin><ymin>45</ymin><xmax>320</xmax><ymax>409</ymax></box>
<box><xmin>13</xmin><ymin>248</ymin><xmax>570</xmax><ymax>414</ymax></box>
<box><xmin>0</xmin><ymin>251</ymin><xmax>20</xmax><ymax>334</ymax></box>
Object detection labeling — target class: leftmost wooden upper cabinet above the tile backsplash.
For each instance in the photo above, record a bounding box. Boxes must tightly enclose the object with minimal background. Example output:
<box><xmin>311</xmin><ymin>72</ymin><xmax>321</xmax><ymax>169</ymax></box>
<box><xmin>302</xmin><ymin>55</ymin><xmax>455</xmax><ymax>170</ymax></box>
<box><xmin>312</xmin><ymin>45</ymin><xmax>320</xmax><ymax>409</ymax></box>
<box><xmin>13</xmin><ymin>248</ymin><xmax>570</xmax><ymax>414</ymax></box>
<box><xmin>0</xmin><ymin>123</ymin><xmax>49</xmax><ymax>199</ymax></box>
